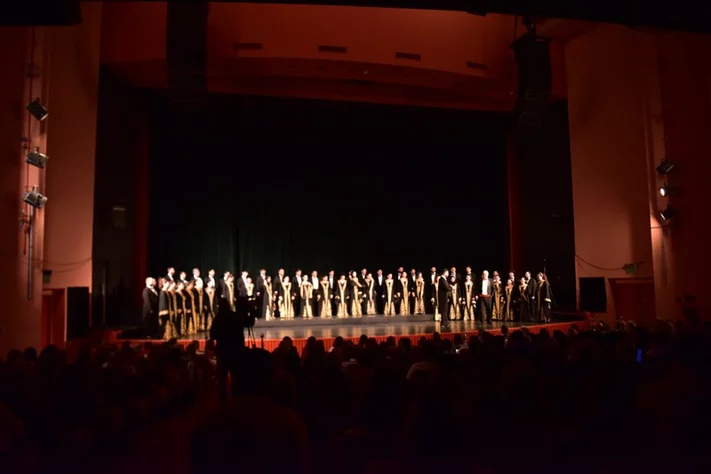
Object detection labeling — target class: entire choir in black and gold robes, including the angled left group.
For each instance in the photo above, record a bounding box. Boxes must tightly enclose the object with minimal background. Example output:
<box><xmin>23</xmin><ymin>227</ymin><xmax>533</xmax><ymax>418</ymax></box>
<box><xmin>143</xmin><ymin>267</ymin><xmax>552</xmax><ymax>339</ymax></box>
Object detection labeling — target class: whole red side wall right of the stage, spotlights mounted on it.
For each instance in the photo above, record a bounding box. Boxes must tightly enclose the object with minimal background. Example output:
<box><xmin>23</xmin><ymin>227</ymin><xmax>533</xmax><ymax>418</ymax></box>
<box><xmin>566</xmin><ymin>25</ymin><xmax>711</xmax><ymax>319</ymax></box>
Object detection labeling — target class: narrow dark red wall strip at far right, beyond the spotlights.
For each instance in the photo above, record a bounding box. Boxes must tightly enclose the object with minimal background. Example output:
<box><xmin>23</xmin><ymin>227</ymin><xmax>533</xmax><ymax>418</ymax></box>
<box><xmin>658</xmin><ymin>34</ymin><xmax>711</xmax><ymax>318</ymax></box>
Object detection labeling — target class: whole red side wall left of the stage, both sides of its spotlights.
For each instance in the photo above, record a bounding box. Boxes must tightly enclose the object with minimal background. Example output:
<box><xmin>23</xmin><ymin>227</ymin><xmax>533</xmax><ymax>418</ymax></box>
<box><xmin>0</xmin><ymin>4</ymin><xmax>101</xmax><ymax>353</ymax></box>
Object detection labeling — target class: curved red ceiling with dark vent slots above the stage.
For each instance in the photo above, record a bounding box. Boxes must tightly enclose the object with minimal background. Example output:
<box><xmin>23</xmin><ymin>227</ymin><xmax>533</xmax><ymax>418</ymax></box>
<box><xmin>102</xmin><ymin>2</ymin><xmax>540</xmax><ymax>111</ymax></box>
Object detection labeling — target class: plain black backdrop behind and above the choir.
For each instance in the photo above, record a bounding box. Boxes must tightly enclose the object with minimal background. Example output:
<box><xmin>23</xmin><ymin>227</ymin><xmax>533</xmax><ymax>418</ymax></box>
<box><xmin>149</xmin><ymin>96</ymin><xmax>509</xmax><ymax>275</ymax></box>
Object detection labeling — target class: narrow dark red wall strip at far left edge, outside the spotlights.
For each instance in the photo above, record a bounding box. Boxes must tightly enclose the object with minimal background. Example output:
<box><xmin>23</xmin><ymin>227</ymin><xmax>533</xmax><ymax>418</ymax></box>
<box><xmin>0</xmin><ymin>28</ymin><xmax>46</xmax><ymax>354</ymax></box>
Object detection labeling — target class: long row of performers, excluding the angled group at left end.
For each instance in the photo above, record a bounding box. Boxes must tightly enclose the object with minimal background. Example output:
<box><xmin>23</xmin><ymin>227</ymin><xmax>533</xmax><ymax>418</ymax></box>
<box><xmin>221</xmin><ymin>270</ymin><xmax>551</xmax><ymax>322</ymax></box>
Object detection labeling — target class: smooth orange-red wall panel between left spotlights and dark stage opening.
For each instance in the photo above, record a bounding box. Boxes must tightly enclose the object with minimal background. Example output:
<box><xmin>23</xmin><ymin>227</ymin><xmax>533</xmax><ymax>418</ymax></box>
<box><xmin>44</xmin><ymin>3</ymin><xmax>101</xmax><ymax>291</ymax></box>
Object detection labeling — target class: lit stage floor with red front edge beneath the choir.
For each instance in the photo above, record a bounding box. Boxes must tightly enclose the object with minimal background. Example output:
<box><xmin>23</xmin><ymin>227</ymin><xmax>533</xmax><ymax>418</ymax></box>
<box><xmin>105</xmin><ymin>315</ymin><xmax>584</xmax><ymax>351</ymax></box>
